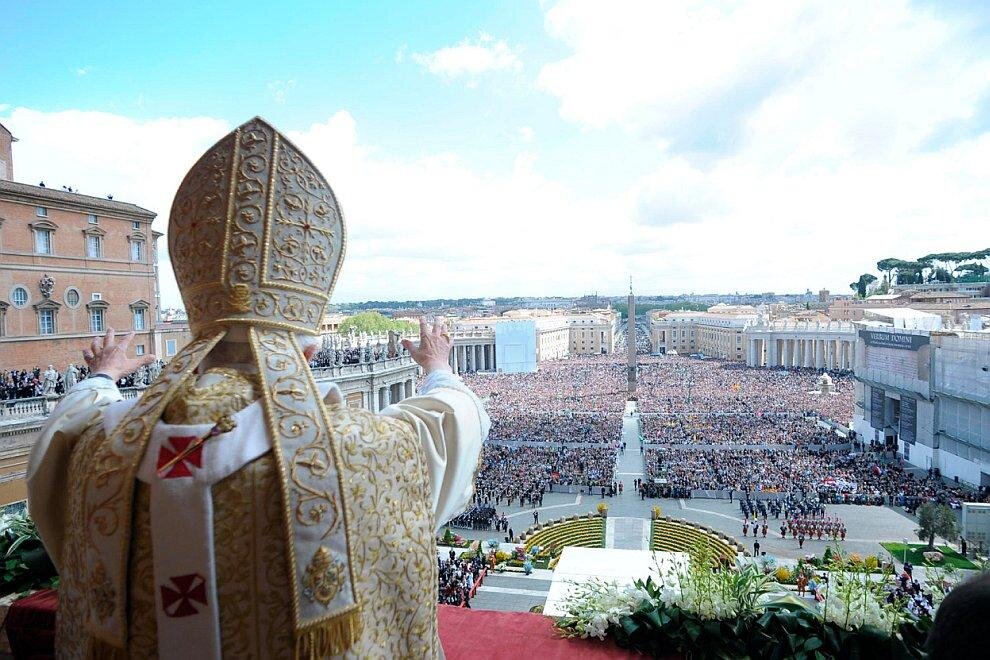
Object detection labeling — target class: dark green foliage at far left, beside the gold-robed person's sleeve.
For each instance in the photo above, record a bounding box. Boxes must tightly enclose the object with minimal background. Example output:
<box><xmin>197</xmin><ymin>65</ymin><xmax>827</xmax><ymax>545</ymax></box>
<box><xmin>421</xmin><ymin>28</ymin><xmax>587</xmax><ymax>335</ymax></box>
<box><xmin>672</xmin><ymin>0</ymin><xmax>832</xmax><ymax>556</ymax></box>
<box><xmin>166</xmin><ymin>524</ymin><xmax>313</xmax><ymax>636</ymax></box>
<box><xmin>0</xmin><ymin>513</ymin><xmax>58</xmax><ymax>596</ymax></box>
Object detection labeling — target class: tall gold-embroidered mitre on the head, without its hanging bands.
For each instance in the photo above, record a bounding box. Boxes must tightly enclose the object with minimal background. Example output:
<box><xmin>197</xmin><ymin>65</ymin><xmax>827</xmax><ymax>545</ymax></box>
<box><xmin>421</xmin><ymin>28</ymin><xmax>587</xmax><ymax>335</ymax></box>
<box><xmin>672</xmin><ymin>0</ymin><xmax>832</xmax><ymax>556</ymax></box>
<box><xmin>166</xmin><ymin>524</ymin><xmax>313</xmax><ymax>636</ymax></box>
<box><xmin>168</xmin><ymin>117</ymin><xmax>345</xmax><ymax>337</ymax></box>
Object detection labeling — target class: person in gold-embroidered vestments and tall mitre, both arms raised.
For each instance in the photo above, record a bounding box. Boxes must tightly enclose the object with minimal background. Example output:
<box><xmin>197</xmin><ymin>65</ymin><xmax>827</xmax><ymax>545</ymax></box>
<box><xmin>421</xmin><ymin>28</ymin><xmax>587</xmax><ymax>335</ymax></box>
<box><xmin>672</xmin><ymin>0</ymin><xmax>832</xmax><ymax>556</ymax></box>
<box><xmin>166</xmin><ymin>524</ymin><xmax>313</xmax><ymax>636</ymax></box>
<box><xmin>28</xmin><ymin>118</ymin><xmax>490</xmax><ymax>658</ymax></box>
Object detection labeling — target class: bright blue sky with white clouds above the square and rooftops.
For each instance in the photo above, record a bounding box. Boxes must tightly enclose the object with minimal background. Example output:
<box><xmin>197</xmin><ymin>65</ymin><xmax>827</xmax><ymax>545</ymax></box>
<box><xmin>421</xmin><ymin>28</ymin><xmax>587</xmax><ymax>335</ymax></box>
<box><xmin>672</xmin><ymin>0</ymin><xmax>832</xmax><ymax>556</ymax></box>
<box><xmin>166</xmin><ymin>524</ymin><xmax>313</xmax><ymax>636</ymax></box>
<box><xmin>0</xmin><ymin>0</ymin><xmax>990</xmax><ymax>306</ymax></box>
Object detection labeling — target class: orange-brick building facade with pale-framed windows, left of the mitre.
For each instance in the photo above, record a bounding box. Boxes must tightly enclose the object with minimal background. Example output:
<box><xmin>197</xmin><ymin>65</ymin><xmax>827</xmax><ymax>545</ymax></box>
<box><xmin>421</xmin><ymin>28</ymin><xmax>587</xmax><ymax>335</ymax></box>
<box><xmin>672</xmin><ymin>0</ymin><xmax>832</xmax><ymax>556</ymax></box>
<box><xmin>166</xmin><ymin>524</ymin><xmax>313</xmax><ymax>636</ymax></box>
<box><xmin>0</xmin><ymin>181</ymin><xmax>160</xmax><ymax>369</ymax></box>
